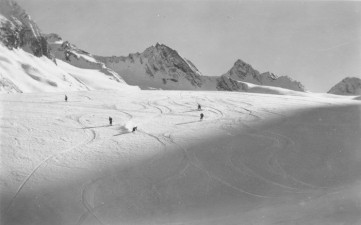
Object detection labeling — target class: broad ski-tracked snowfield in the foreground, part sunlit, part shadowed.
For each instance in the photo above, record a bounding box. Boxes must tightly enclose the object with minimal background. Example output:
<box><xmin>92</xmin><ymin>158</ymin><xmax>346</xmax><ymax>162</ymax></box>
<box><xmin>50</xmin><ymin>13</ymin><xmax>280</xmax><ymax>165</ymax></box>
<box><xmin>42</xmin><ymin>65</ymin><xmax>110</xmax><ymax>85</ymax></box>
<box><xmin>0</xmin><ymin>90</ymin><xmax>361</xmax><ymax>225</ymax></box>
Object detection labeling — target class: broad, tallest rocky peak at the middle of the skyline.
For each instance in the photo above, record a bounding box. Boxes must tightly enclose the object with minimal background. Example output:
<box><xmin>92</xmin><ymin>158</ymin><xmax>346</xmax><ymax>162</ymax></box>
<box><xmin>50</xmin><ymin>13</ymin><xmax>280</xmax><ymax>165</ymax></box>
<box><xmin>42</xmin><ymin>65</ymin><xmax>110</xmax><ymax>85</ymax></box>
<box><xmin>96</xmin><ymin>43</ymin><xmax>203</xmax><ymax>90</ymax></box>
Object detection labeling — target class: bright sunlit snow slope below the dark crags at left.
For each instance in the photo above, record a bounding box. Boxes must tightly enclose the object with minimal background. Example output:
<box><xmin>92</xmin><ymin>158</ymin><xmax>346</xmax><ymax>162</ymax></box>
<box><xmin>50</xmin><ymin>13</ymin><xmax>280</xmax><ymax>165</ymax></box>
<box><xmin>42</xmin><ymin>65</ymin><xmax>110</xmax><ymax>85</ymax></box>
<box><xmin>0</xmin><ymin>43</ymin><xmax>136</xmax><ymax>93</ymax></box>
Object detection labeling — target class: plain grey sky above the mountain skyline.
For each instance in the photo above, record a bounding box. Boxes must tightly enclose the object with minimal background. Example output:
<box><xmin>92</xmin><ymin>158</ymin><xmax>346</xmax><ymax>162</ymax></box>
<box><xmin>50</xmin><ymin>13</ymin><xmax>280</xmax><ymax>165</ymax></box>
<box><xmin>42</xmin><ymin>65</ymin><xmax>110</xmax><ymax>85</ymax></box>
<box><xmin>16</xmin><ymin>0</ymin><xmax>361</xmax><ymax>92</ymax></box>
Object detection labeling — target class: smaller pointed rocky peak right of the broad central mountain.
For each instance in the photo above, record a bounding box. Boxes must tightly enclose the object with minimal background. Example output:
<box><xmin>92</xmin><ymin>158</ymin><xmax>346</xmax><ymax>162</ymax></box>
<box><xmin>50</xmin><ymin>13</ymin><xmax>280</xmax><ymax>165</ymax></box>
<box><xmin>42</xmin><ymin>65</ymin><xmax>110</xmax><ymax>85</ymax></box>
<box><xmin>223</xmin><ymin>59</ymin><xmax>305</xmax><ymax>91</ymax></box>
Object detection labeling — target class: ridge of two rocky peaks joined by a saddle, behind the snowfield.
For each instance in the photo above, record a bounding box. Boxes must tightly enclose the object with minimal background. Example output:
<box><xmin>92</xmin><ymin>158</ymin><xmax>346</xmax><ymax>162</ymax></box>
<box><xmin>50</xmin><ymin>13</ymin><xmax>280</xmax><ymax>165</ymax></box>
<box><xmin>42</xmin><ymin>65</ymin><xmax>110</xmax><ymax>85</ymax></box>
<box><xmin>95</xmin><ymin>43</ymin><xmax>305</xmax><ymax>91</ymax></box>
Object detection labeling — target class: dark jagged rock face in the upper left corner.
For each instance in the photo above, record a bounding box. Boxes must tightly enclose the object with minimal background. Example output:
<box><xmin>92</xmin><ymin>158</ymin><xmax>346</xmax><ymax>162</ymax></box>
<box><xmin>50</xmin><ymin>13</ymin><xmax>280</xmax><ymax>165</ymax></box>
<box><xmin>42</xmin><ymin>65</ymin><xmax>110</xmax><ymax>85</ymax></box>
<box><xmin>0</xmin><ymin>0</ymin><xmax>52</xmax><ymax>58</ymax></box>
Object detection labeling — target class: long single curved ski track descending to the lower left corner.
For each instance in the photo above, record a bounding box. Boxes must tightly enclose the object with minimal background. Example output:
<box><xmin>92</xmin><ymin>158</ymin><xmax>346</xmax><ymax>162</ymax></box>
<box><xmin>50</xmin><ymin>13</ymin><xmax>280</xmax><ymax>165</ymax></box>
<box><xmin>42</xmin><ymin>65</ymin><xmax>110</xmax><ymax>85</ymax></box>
<box><xmin>6</xmin><ymin>121</ymin><xmax>96</xmax><ymax>212</ymax></box>
